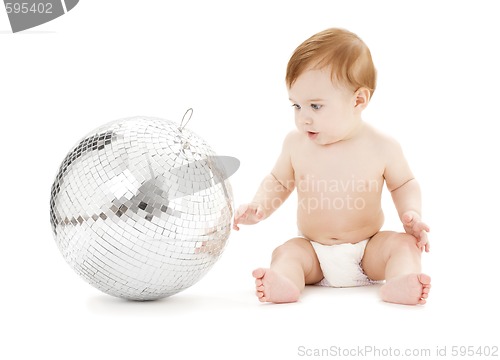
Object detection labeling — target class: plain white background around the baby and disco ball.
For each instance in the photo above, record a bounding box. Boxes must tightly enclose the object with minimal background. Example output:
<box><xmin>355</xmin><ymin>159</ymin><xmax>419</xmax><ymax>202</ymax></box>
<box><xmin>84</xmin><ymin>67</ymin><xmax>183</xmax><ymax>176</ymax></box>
<box><xmin>0</xmin><ymin>0</ymin><xmax>500</xmax><ymax>359</ymax></box>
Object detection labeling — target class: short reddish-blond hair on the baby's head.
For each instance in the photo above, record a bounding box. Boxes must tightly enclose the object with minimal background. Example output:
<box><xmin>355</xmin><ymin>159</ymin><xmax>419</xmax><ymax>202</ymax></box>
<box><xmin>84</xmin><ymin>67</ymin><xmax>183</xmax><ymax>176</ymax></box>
<box><xmin>286</xmin><ymin>28</ymin><xmax>377</xmax><ymax>96</ymax></box>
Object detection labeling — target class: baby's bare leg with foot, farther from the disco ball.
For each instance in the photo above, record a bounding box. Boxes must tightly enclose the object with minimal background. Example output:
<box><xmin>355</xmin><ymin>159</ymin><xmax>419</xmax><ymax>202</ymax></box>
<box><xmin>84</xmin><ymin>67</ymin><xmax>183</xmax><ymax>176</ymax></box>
<box><xmin>362</xmin><ymin>231</ymin><xmax>431</xmax><ymax>305</ymax></box>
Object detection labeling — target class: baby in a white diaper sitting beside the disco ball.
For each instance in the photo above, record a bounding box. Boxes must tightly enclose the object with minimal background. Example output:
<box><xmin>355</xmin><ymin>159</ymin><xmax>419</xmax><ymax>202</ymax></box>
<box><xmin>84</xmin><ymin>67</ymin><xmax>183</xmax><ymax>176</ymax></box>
<box><xmin>233</xmin><ymin>29</ymin><xmax>431</xmax><ymax>305</ymax></box>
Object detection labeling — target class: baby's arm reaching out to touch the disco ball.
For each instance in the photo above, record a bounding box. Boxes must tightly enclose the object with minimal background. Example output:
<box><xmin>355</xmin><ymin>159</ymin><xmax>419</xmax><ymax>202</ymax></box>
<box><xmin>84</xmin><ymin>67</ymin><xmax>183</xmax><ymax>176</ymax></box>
<box><xmin>233</xmin><ymin>133</ymin><xmax>295</xmax><ymax>230</ymax></box>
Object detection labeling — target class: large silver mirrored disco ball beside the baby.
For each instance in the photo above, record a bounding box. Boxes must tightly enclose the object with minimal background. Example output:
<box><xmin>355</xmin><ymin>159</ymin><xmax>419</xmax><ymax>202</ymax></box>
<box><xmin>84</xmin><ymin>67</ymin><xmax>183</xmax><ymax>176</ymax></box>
<box><xmin>50</xmin><ymin>117</ymin><xmax>239</xmax><ymax>300</ymax></box>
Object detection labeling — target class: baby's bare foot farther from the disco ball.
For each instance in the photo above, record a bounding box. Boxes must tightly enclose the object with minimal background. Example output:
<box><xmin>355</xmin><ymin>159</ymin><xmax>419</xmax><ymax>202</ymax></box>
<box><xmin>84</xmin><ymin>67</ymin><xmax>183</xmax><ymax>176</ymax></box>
<box><xmin>380</xmin><ymin>274</ymin><xmax>431</xmax><ymax>305</ymax></box>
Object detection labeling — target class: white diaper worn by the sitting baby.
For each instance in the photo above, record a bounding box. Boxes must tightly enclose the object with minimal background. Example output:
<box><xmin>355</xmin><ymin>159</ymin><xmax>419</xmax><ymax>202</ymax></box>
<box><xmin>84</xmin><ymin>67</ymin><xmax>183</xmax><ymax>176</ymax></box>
<box><xmin>311</xmin><ymin>239</ymin><xmax>377</xmax><ymax>287</ymax></box>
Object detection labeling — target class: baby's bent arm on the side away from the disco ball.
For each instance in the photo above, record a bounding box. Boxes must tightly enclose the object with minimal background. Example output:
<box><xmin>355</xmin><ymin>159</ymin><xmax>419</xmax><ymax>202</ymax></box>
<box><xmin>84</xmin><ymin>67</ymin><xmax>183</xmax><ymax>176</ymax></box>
<box><xmin>384</xmin><ymin>140</ymin><xmax>429</xmax><ymax>252</ymax></box>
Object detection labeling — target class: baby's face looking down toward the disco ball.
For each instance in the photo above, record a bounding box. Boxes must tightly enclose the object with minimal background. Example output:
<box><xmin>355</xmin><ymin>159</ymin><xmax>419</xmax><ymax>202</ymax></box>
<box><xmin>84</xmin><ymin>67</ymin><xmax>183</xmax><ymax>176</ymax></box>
<box><xmin>288</xmin><ymin>68</ymin><xmax>361</xmax><ymax>145</ymax></box>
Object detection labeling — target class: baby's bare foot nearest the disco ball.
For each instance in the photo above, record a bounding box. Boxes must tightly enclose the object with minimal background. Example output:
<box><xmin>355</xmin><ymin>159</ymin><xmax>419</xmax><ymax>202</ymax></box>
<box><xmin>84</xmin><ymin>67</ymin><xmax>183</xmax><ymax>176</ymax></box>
<box><xmin>252</xmin><ymin>268</ymin><xmax>300</xmax><ymax>303</ymax></box>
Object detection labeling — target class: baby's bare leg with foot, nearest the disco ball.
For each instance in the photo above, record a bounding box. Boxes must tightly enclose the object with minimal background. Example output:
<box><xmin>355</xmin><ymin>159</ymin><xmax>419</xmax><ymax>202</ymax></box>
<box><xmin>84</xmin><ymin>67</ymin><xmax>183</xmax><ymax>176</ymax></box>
<box><xmin>252</xmin><ymin>238</ymin><xmax>323</xmax><ymax>303</ymax></box>
